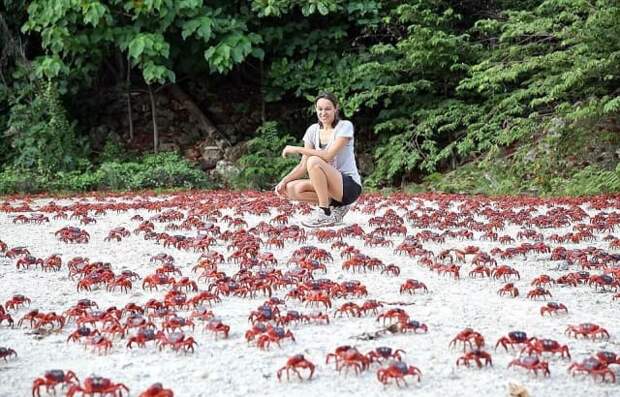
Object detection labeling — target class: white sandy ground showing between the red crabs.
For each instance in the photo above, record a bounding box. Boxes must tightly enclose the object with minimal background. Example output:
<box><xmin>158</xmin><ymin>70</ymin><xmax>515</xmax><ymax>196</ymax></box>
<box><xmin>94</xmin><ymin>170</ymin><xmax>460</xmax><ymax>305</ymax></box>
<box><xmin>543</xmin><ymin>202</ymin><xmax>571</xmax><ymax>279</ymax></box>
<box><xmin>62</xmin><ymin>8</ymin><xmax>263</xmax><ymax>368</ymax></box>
<box><xmin>0</xmin><ymin>194</ymin><xmax>620</xmax><ymax>397</ymax></box>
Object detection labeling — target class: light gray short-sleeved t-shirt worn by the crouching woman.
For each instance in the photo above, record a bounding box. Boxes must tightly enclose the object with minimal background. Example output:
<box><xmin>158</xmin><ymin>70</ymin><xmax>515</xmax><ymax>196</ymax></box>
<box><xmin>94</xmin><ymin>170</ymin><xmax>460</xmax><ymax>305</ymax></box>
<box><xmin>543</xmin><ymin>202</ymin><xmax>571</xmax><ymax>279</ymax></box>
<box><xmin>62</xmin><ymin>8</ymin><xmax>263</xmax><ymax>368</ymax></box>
<box><xmin>304</xmin><ymin>120</ymin><xmax>362</xmax><ymax>186</ymax></box>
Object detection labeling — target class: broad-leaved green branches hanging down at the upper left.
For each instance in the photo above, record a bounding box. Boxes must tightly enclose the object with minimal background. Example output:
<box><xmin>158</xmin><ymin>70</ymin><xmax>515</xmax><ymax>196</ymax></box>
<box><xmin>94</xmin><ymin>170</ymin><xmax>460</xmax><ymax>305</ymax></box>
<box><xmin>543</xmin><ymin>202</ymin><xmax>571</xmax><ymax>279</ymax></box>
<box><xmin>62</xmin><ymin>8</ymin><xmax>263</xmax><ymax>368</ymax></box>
<box><xmin>23</xmin><ymin>0</ymin><xmax>263</xmax><ymax>84</ymax></box>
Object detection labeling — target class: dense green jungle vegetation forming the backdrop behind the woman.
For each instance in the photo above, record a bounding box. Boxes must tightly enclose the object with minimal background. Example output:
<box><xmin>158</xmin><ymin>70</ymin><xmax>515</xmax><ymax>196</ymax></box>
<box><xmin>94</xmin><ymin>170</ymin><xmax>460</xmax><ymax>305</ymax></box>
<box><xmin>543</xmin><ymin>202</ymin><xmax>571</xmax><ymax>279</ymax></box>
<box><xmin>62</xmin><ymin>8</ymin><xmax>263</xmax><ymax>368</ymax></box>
<box><xmin>0</xmin><ymin>0</ymin><xmax>620</xmax><ymax>195</ymax></box>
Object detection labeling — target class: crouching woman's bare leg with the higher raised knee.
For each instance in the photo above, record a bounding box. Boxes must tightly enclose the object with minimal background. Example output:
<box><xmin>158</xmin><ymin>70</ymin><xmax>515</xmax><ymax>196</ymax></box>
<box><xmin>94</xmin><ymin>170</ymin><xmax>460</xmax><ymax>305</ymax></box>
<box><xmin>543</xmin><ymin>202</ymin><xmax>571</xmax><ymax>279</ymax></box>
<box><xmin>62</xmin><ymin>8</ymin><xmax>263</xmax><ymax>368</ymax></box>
<box><xmin>306</xmin><ymin>156</ymin><xmax>343</xmax><ymax>207</ymax></box>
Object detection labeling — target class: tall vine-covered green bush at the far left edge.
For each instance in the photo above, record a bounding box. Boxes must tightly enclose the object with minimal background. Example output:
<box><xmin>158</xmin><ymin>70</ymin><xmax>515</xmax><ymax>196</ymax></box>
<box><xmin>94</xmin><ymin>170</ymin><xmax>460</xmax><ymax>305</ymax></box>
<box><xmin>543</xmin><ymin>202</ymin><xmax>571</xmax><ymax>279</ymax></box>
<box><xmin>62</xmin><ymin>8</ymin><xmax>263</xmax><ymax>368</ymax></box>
<box><xmin>5</xmin><ymin>81</ymin><xmax>83</xmax><ymax>175</ymax></box>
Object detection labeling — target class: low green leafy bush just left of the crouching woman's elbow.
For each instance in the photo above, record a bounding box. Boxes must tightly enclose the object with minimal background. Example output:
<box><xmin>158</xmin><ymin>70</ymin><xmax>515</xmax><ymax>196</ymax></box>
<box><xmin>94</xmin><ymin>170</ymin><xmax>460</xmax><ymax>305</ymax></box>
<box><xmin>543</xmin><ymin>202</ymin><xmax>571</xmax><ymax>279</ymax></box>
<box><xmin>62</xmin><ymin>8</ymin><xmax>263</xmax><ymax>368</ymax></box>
<box><xmin>233</xmin><ymin>121</ymin><xmax>299</xmax><ymax>190</ymax></box>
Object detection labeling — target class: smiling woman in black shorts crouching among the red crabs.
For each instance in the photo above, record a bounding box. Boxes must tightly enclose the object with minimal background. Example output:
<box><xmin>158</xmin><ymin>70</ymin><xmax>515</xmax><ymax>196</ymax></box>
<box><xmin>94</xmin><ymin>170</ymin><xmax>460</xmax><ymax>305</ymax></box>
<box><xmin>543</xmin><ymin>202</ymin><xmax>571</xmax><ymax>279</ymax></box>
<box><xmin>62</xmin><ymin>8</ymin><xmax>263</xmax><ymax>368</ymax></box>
<box><xmin>275</xmin><ymin>93</ymin><xmax>362</xmax><ymax>227</ymax></box>
